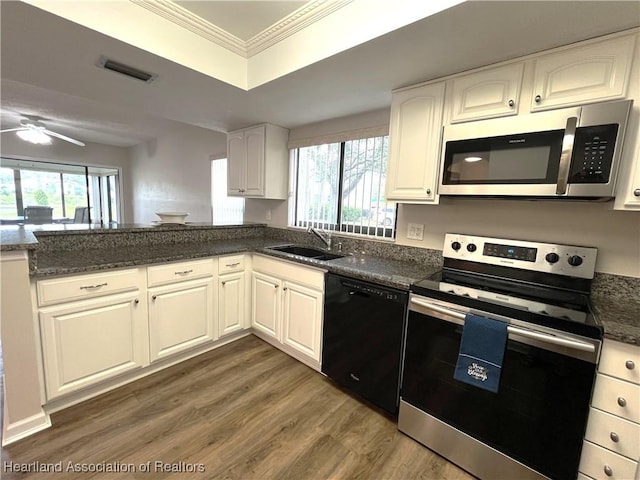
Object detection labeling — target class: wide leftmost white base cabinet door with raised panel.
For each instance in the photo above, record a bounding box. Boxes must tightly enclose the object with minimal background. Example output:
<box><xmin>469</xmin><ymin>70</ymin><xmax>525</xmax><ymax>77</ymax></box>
<box><xmin>39</xmin><ymin>291</ymin><xmax>147</xmax><ymax>399</ymax></box>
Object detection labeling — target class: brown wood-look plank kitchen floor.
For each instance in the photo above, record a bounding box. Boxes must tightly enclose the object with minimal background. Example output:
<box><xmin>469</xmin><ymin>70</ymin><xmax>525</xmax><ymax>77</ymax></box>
<box><xmin>0</xmin><ymin>335</ymin><xmax>474</xmax><ymax>480</ymax></box>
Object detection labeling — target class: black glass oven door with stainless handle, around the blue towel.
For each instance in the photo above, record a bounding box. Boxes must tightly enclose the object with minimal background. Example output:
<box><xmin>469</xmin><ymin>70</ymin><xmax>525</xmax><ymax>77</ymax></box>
<box><xmin>400</xmin><ymin>295</ymin><xmax>599</xmax><ymax>480</ymax></box>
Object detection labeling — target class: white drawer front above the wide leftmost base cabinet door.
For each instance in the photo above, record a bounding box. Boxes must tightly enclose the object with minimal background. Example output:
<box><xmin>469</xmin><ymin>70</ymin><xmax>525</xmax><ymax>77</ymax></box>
<box><xmin>36</xmin><ymin>269</ymin><xmax>144</xmax><ymax>307</ymax></box>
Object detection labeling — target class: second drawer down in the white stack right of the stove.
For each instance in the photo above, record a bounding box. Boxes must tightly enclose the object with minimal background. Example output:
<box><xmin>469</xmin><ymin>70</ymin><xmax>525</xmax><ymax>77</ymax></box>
<box><xmin>591</xmin><ymin>373</ymin><xmax>640</xmax><ymax>423</ymax></box>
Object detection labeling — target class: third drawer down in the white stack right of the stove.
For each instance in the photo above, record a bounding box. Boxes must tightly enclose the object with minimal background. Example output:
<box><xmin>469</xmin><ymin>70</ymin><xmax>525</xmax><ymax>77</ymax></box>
<box><xmin>585</xmin><ymin>408</ymin><xmax>640</xmax><ymax>460</ymax></box>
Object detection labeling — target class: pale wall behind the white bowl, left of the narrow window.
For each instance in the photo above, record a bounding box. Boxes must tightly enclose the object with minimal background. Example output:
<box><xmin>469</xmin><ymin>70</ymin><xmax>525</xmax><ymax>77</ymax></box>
<box><xmin>130</xmin><ymin>122</ymin><xmax>227</xmax><ymax>224</ymax></box>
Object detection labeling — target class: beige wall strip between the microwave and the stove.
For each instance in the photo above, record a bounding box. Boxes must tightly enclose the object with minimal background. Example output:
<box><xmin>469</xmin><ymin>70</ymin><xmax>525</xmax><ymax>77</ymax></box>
<box><xmin>396</xmin><ymin>198</ymin><xmax>640</xmax><ymax>277</ymax></box>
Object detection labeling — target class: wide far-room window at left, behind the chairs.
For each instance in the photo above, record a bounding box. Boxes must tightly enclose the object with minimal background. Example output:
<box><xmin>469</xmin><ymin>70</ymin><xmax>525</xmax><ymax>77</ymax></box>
<box><xmin>0</xmin><ymin>158</ymin><xmax>120</xmax><ymax>224</ymax></box>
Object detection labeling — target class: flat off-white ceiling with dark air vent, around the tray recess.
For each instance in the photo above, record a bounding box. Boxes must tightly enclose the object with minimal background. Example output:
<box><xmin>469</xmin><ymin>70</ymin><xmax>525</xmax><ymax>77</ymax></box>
<box><xmin>0</xmin><ymin>1</ymin><xmax>640</xmax><ymax>146</ymax></box>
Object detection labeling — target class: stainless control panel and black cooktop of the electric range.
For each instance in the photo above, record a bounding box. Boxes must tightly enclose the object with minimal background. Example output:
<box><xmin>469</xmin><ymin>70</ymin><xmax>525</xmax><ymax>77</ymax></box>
<box><xmin>411</xmin><ymin>234</ymin><xmax>603</xmax><ymax>339</ymax></box>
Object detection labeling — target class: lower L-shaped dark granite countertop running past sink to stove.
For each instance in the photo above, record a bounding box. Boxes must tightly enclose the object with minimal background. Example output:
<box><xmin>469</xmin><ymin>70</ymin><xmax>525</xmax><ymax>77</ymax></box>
<box><xmin>33</xmin><ymin>238</ymin><xmax>439</xmax><ymax>289</ymax></box>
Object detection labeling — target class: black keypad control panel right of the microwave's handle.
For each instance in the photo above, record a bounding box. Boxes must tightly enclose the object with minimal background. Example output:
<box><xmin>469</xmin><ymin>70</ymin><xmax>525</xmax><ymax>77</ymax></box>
<box><xmin>569</xmin><ymin>123</ymin><xmax>618</xmax><ymax>183</ymax></box>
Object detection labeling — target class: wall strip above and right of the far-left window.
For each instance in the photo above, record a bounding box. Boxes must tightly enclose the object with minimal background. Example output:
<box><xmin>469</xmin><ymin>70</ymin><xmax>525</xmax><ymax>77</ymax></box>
<box><xmin>0</xmin><ymin>134</ymin><xmax>133</xmax><ymax>223</ymax></box>
